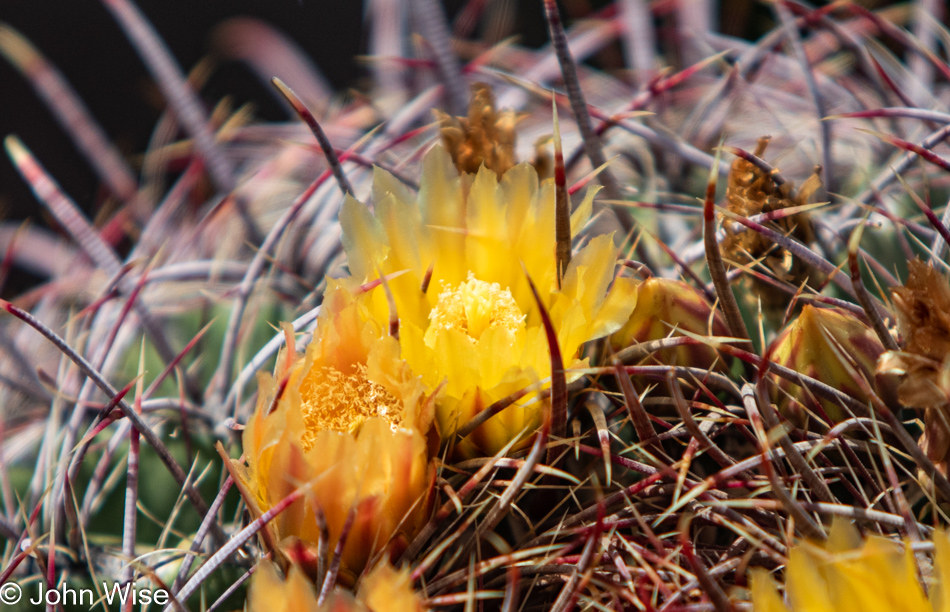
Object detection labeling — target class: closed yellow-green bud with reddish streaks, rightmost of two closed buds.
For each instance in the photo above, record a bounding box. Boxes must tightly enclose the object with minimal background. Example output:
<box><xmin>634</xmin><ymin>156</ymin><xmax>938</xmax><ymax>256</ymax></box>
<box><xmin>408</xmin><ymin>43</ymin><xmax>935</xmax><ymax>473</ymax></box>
<box><xmin>772</xmin><ymin>304</ymin><xmax>884</xmax><ymax>422</ymax></box>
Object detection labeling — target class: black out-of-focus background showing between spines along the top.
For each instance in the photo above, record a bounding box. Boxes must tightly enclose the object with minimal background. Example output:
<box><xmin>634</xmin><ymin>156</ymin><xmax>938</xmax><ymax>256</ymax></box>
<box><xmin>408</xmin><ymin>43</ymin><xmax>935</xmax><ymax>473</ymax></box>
<box><xmin>0</xmin><ymin>0</ymin><xmax>912</xmax><ymax>296</ymax></box>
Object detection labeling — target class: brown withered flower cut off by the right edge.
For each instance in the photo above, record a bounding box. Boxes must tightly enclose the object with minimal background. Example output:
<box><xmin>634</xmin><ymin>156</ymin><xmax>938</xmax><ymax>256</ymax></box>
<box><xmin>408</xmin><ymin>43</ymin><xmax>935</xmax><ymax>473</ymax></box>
<box><xmin>877</xmin><ymin>259</ymin><xmax>950</xmax><ymax>474</ymax></box>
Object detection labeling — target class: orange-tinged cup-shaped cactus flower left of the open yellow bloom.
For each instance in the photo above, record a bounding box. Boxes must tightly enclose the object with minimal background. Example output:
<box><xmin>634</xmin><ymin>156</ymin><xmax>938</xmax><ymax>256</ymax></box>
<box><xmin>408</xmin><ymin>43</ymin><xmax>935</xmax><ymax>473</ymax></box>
<box><xmin>236</xmin><ymin>284</ymin><xmax>432</xmax><ymax>579</ymax></box>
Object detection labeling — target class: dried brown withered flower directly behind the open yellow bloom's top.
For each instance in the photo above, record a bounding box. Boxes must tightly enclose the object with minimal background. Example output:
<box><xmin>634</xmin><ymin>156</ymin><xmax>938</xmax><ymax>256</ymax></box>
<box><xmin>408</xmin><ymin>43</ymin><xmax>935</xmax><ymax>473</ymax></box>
<box><xmin>435</xmin><ymin>83</ymin><xmax>518</xmax><ymax>178</ymax></box>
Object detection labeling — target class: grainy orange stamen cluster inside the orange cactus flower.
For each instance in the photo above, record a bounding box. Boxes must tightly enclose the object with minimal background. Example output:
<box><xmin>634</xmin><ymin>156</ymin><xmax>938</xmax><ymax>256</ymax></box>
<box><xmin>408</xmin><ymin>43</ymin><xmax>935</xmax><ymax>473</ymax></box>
<box><xmin>301</xmin><ymin>364</ymin><xmax>402</xmax><ymax>451</ymax></box>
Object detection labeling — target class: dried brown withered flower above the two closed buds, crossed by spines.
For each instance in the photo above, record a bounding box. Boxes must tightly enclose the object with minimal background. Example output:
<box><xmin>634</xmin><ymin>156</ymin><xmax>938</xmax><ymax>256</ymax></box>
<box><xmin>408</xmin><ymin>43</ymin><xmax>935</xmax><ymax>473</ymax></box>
<box><xmin>723</xmin><ymin>136</ymin><xmax>821</xmax><ymax>312</ymax></box>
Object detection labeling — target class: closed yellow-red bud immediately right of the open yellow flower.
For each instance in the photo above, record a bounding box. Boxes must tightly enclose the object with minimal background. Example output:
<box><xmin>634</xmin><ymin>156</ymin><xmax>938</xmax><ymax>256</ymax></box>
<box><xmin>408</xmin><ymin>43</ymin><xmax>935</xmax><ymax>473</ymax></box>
<box><xmin>610</xmin><ymin>277</ymin><xmax>729</xmax><ymax>369</ymax></box>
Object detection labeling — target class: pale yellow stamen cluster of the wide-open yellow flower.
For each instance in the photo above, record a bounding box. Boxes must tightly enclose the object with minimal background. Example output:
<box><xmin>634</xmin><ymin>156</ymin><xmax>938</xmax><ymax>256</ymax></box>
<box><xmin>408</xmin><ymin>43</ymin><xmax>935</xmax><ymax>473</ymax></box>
<box><xmin>425</xmin><ymin>272</ymin><xmax>525</xmax><ymax>347</ymax></box>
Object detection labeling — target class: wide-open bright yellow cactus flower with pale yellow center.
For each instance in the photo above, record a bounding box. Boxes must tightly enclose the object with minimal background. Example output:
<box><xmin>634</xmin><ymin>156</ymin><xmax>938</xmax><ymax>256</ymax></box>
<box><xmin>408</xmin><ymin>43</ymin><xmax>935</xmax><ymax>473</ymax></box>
<box><xmin>340</xmin><ymin>146</ymin><xmax>634</xmax><ymax>456</ymax></box>
